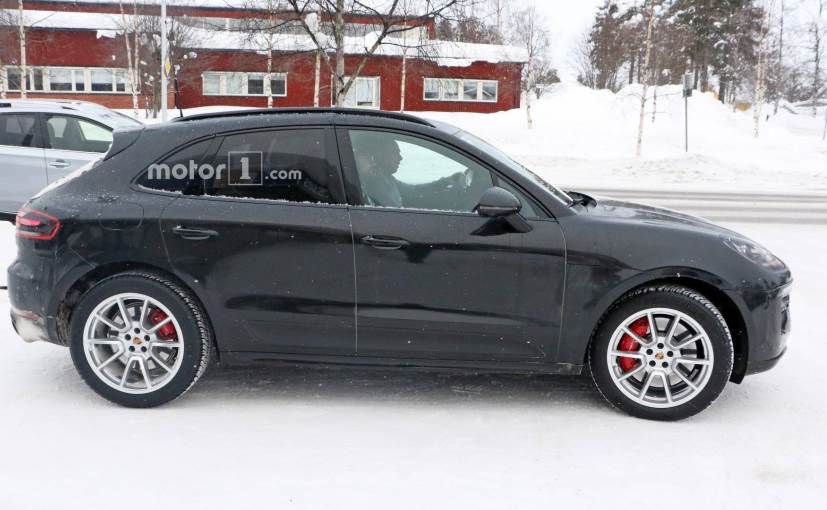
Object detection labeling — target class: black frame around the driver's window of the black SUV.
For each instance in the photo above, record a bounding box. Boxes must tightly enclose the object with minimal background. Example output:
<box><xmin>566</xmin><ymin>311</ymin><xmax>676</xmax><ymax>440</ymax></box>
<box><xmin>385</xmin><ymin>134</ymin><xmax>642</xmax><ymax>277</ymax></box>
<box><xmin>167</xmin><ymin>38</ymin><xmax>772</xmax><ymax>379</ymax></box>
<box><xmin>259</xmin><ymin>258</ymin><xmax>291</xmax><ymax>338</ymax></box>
<box><xmin>336</xmin><ymin>124</ymin><xmax>557</xmax><ymax>222</ymax></box>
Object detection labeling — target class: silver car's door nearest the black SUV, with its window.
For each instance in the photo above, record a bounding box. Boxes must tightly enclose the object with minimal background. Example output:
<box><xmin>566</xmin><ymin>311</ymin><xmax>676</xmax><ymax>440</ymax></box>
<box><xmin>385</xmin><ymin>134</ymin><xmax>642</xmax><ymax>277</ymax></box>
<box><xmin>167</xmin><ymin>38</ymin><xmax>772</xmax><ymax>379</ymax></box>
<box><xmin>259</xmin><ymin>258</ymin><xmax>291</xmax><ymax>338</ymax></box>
<box><xmin>42</xmin><ymin>113</ymin><xmax>112</xmax><ymax>182</ymax></box>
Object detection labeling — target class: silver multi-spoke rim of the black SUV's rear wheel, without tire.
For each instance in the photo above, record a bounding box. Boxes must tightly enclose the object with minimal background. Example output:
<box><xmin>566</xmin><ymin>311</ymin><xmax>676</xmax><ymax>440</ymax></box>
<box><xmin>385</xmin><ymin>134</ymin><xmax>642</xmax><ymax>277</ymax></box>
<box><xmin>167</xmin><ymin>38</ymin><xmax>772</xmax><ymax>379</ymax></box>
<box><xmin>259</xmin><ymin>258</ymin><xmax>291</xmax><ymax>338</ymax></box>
<box><xmin>83</xmin><ymin>293</ymin><xmax>184</xmax><ymax>394</ymax></box>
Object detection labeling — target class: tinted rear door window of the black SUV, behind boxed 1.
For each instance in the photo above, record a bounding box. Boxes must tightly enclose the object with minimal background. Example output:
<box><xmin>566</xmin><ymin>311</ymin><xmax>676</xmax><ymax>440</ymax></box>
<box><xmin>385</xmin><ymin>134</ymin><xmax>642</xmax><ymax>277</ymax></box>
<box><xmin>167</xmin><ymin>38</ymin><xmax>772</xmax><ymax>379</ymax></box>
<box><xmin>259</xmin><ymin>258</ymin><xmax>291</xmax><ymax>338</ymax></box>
<box><xmin>205</xmin><ymin>129</ymin><xmax>339</xmax><ymax>204</ymax></box>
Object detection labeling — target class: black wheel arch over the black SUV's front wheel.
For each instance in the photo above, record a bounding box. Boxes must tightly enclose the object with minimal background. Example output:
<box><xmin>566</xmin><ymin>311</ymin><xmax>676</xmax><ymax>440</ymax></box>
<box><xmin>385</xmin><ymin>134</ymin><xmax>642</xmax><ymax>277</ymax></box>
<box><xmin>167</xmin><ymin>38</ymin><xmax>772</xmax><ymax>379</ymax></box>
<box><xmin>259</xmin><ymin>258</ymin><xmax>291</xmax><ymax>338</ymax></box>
<box><xmin>583</xmin><ymin>276</ymin><xmax>749</xmax><ymax>383</ymax></box>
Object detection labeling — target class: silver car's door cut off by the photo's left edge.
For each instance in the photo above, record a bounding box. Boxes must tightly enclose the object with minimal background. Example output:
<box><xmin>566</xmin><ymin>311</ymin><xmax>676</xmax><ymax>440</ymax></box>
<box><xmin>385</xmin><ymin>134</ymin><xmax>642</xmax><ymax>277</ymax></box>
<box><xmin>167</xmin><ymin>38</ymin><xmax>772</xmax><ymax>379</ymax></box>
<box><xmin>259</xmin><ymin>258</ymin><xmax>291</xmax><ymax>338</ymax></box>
<box><xmin>0</xmin><ymin>113</ymin><xmax>47</xmax><ymax>213</ymax></box>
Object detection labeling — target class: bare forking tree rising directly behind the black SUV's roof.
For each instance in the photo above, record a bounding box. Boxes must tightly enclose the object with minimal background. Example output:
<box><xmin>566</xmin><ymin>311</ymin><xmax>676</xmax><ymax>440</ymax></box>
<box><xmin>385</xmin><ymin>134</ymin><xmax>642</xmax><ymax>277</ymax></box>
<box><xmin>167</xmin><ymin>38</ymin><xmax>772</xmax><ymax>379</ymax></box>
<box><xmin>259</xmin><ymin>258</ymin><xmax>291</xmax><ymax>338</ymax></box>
<box><xmin>286</xmin><ymin>0</ymin><xmax>467</xmax><ymax>106</ymax></box>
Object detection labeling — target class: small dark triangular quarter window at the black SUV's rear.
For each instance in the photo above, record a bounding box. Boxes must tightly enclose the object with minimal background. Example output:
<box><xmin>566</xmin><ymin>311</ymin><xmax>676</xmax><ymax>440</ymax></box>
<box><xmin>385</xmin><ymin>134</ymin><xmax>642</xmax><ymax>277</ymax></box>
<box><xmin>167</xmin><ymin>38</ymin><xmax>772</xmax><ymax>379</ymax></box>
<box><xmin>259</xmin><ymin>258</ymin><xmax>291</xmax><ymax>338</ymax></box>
<box><xmin>137</xmin><ymin>139</ymin><xmax>212</xmax><ymax>195</ymax></box>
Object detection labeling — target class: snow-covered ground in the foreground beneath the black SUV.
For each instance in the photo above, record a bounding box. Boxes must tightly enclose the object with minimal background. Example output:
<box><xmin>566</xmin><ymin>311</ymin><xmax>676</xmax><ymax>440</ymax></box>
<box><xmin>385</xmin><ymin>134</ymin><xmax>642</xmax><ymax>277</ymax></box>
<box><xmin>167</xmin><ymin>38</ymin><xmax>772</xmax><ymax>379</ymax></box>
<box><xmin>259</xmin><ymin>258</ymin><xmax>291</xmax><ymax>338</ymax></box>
<box><xmin>0</xmin><ymin>217</ymin><xmax>827</xmax><ymax>510</ymax></box>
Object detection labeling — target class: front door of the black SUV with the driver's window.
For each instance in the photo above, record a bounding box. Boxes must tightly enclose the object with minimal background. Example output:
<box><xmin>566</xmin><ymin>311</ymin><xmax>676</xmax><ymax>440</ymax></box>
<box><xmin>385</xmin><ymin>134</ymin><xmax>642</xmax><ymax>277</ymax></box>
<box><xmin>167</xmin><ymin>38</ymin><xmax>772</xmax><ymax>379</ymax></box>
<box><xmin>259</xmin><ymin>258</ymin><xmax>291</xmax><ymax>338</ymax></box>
<box><xmin>339</xmin><ymin>129</ymin><xmax>564</xmax><ymax>362</ymax></box>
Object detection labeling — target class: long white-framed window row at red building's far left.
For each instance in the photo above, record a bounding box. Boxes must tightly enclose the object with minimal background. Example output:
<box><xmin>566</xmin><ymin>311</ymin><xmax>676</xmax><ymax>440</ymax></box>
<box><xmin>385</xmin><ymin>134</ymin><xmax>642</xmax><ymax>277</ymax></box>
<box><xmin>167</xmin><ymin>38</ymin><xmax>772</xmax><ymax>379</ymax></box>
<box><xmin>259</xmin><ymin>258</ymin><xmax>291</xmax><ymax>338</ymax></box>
<box><xmin>0</xmin><ymin>66</ymin><xmax>129</xmax><ymax>94</ymax></box>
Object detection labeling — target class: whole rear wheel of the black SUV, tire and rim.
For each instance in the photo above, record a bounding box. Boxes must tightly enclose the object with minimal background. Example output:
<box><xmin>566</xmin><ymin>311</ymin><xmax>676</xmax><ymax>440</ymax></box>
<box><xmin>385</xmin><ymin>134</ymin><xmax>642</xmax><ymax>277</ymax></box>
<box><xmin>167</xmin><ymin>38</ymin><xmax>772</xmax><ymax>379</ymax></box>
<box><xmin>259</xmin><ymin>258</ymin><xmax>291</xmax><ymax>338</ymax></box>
<box><xmin>70</xmin><ymin>272</ymin><xmax>212</xmax><ymax>407</ymax></box>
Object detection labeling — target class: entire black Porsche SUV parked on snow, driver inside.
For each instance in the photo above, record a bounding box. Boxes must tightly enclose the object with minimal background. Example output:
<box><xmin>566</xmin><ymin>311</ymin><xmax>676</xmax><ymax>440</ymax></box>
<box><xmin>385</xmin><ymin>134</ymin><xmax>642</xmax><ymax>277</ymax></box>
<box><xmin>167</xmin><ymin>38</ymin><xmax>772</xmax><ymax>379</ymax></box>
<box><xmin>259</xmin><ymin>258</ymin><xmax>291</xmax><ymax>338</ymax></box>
<box><xmin>9</xmin><ymin>109</ymin><xmax>791</xmax><ymax>420</ymax></box>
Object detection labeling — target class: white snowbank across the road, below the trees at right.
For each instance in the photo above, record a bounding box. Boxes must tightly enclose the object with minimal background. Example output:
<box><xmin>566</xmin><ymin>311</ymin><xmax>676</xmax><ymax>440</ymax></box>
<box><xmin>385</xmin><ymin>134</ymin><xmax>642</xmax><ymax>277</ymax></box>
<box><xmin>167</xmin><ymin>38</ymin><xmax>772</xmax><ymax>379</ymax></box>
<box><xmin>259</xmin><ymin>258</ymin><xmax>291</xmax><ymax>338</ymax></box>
<box><xmin>424</xmin><ymin>84</ymin><xmax>827</xmax><ymax>192</ymax></box>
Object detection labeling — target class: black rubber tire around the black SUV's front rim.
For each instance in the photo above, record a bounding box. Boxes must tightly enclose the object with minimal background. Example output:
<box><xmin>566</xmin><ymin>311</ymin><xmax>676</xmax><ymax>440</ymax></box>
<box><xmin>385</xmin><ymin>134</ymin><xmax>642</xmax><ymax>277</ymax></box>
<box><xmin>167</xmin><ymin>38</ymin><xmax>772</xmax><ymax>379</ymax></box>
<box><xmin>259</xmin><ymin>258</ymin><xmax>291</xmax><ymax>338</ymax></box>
<box><xmin>588</xmin><ymin>285</ymin><xmax>733</xmax><ymax>421</ymax></box>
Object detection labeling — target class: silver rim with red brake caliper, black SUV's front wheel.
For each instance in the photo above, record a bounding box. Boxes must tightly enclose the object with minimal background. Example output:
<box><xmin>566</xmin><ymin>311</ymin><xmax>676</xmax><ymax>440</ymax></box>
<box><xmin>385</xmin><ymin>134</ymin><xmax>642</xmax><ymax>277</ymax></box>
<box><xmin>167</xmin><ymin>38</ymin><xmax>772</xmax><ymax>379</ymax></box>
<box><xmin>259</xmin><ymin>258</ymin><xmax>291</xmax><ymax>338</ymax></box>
<box><xmin>606</xmin><ymin>308</ymin><xmax>714</xmax><ymax>408</ymax></box>
